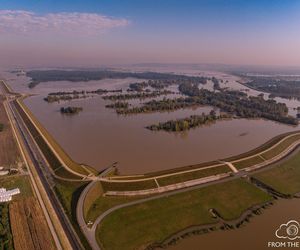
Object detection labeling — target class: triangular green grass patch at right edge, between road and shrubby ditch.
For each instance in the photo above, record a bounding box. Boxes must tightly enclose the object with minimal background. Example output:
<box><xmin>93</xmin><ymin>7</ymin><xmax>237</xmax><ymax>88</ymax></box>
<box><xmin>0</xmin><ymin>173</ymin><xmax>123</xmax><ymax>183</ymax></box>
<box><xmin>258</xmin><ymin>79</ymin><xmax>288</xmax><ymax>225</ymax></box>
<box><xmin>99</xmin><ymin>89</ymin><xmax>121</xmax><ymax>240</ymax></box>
<box><xmin>254</xmin><ymin>152</ymin><xmax>300</xmax><ymax>195</ymax></box>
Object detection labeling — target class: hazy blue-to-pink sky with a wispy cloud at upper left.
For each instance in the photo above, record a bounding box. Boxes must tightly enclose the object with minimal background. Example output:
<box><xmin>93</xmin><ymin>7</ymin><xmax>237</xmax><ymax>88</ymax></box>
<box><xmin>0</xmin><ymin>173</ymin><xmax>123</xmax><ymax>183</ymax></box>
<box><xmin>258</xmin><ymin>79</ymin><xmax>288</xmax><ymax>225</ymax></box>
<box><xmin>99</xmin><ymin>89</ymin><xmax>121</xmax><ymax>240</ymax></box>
<box><xmin>0</xmin><ymin>0</ymin><xmax>300</xmax><ymax>66</ymax></box>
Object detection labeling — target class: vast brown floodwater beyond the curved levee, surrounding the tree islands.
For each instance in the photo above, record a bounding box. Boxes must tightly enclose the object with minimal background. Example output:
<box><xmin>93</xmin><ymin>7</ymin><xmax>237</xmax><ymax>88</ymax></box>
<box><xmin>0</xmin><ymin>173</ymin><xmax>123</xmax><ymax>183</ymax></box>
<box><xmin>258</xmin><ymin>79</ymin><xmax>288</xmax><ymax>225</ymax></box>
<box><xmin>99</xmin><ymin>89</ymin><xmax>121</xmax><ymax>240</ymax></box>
<box><xmin>4</xmin><ymin>70</ymin><xmax>300</xmax><ymax>174</ymax></box>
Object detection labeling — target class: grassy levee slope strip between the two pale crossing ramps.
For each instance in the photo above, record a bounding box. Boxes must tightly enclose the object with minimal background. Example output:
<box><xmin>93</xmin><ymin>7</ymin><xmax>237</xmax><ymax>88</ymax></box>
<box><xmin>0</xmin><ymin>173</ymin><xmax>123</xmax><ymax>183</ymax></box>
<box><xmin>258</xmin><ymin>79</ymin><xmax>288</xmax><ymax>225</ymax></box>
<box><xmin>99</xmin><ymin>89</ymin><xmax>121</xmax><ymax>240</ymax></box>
<box><xmin>157</xmin><ymin>164</ymin><xmax>231</xmax><ymax>186</ymax></box>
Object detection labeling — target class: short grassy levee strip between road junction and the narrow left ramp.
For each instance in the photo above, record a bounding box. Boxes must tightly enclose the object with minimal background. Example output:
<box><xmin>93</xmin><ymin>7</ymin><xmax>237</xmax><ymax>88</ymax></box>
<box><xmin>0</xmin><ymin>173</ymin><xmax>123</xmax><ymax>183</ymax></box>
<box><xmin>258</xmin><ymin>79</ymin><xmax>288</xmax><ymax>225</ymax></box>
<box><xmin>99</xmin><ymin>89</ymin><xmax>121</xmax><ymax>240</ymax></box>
<box><xmin>101</xmin><ymin>179</ymin><xmax>157</xmax><ymax>192</ymax></box>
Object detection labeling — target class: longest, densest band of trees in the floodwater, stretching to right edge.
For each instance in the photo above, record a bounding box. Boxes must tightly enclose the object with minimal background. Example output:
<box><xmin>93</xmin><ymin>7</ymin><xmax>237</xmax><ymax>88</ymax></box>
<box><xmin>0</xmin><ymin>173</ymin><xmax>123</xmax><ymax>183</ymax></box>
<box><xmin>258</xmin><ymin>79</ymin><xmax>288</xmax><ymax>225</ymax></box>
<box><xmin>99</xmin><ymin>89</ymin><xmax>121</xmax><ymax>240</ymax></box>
<box><xmin>110</xmin><ymin>83</ymin><xmax>298</xmax><ymax>125</ymax></box>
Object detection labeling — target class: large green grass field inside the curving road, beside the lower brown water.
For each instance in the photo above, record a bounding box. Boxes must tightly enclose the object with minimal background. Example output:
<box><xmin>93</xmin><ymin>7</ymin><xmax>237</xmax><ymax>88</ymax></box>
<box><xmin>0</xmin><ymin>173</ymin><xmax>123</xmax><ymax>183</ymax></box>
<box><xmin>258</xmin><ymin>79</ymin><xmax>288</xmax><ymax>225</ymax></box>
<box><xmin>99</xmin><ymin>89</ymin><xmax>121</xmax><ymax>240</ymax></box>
<box><xmin>96</xmin><ymin>179</ymin><xmax>272</xmax><ymax>250</ymax></box>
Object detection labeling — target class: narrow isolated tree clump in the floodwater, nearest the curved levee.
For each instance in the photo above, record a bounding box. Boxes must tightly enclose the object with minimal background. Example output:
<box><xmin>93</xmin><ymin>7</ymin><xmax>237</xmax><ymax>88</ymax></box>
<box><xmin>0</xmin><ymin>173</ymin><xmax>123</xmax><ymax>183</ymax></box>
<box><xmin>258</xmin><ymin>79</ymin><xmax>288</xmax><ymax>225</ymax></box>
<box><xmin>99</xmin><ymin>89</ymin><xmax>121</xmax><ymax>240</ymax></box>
<box><xmin>146</xmin><ymin>110</ymin><xmax>232</xmax><ymax>132</ymax></box>
